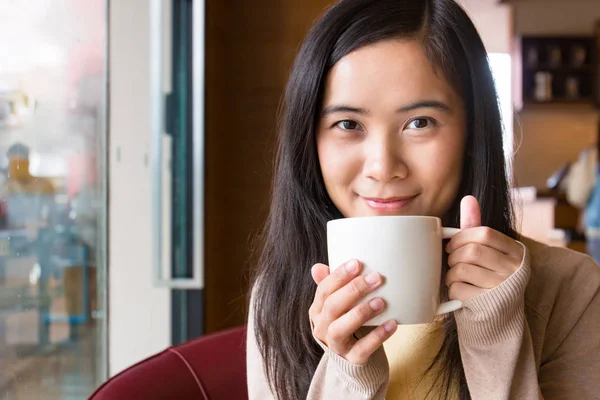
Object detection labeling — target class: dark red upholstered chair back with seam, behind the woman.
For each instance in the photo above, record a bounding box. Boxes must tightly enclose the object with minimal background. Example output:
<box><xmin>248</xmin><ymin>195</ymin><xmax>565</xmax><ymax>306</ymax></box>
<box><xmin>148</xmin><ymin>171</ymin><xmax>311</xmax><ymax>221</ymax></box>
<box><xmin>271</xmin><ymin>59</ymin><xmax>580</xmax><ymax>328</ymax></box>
<box><xmin>89</xmin><ymin>326</ymin><xmax>248</xmax><ymax>400</ymax></box>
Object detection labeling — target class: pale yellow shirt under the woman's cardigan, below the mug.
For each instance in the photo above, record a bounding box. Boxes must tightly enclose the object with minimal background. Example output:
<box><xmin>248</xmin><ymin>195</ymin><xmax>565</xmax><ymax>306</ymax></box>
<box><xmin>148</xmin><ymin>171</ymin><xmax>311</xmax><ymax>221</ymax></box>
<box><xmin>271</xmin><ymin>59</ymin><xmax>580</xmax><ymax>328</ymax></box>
<box><xmin>383</xmin><ymin>322</ymin><xmax>454</xmax><ymax>400</ymax></box>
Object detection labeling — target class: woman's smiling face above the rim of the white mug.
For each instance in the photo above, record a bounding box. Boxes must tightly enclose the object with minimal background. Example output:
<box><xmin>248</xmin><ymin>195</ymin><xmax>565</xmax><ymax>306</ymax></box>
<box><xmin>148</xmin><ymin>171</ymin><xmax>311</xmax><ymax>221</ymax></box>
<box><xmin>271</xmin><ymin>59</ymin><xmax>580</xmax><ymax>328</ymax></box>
<box><xmin>317</xmin><ymin>40</ymin><xmax>466</xmax><ymax>217</ymax></box>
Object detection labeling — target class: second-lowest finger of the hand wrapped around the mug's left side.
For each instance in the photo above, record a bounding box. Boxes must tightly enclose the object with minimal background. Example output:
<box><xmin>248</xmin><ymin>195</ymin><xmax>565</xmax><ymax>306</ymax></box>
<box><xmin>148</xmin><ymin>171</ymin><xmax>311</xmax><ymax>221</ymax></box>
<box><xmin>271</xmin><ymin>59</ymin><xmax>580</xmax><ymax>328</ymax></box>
<box><xmin>327</xmin><ymin>298</ymin><xmax>386</xmax><ymax>354</ymax></box>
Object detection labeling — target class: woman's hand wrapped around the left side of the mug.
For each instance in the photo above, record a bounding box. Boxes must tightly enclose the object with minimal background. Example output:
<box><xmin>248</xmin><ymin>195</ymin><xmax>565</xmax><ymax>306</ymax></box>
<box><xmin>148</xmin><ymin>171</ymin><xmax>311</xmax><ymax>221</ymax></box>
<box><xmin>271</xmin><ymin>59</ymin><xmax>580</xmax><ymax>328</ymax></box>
<box><xmin>308</xmin><ymin>260</ymin><xmax>397</xmax><ymax>365</ymax></box>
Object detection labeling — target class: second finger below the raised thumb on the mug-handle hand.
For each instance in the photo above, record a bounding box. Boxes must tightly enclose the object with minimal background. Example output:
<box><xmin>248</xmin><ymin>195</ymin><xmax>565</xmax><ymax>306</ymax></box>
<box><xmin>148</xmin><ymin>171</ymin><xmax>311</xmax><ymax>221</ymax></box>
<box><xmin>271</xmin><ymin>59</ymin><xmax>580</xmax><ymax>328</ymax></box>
<box><xmin>448</xmin><ymin>243</ymin><xmax>518</xmax><ymax>275</ymax></box>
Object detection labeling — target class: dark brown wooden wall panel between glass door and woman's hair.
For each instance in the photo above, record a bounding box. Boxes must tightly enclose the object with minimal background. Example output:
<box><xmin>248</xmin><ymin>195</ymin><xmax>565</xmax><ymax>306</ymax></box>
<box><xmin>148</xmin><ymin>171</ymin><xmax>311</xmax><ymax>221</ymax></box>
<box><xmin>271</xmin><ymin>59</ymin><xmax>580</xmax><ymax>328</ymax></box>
<box><xmin>205</xmin><ymin>0</ymin><xmax>330</xmax><ymax>332</ymax></box>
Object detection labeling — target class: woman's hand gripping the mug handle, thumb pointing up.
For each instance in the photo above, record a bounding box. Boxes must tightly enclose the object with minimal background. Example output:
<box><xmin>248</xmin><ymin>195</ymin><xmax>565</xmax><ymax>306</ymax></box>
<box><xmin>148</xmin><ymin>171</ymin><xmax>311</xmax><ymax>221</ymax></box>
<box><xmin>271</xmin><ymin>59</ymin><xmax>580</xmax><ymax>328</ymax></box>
<box><xmin>446</xmin><ymin>196</ymin><xmax>524</xmax><ymax>302</ymax></box>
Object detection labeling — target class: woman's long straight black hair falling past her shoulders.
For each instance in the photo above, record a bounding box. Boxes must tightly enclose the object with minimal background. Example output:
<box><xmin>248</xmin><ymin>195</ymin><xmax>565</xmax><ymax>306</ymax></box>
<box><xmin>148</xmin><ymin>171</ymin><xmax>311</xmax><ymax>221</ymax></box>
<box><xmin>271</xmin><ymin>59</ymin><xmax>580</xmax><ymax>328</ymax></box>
<box><xmin>248</xmin><ymin>0</ymin><xmax>515</xmax><ymax>400</ymax></box>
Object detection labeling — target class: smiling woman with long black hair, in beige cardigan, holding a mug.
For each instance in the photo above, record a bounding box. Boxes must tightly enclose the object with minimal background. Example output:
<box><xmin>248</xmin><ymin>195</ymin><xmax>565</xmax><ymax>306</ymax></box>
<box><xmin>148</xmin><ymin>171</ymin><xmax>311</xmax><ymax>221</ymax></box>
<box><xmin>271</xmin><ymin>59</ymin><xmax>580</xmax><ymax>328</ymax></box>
<box><xmin>247</xmin><ymin>0</ymin><xmax>600</xmax><ymax>400</ymax></box>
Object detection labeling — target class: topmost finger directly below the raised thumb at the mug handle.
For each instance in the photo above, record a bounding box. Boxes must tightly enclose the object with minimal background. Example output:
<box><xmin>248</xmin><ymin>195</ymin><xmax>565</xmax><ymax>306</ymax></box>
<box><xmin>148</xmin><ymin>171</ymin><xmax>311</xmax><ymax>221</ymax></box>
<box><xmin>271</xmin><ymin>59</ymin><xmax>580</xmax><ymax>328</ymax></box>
<box><xmin>446</xmin><ymin>226</ymin><xmax>523</xmax><ymax>256</ymax></box>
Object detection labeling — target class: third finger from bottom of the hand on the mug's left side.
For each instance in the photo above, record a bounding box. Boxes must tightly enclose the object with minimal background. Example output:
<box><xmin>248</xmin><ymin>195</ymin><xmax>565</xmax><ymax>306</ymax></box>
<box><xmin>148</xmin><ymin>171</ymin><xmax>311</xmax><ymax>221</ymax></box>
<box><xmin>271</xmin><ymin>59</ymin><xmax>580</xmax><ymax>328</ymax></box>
<box><xmin>322</xmin><ymin>271</ymin><xmax>382</xmax><ymax>322</ymax></box>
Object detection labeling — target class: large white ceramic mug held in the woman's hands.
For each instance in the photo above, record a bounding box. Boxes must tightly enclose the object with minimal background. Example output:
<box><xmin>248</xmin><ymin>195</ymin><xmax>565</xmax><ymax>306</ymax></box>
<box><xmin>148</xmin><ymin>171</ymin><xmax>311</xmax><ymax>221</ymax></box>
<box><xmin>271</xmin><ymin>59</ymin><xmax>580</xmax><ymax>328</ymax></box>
<box><xmin>327</xmin><ymin>216</ymin><xmax>462</xmax><ymax>325</ymax></box>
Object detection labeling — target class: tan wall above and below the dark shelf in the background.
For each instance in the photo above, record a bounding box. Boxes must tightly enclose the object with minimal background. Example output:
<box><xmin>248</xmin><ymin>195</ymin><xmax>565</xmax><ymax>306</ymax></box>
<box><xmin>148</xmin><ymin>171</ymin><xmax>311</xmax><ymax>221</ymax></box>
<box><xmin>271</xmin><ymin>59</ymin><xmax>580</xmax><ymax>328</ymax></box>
<box><xmin>514</xmin><ymin>0</ymin><xmax>600</xmax><ymax>187</ymax></box>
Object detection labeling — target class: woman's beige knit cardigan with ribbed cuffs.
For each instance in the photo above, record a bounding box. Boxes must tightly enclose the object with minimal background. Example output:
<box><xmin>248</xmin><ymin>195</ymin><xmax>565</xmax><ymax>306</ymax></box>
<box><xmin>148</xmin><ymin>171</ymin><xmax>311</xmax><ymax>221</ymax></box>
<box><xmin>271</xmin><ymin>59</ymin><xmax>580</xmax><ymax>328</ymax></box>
<box><xmin>247</xmin><ymin>240</ymin><xmax>600</xmax><ymax>400</ymax></box>
